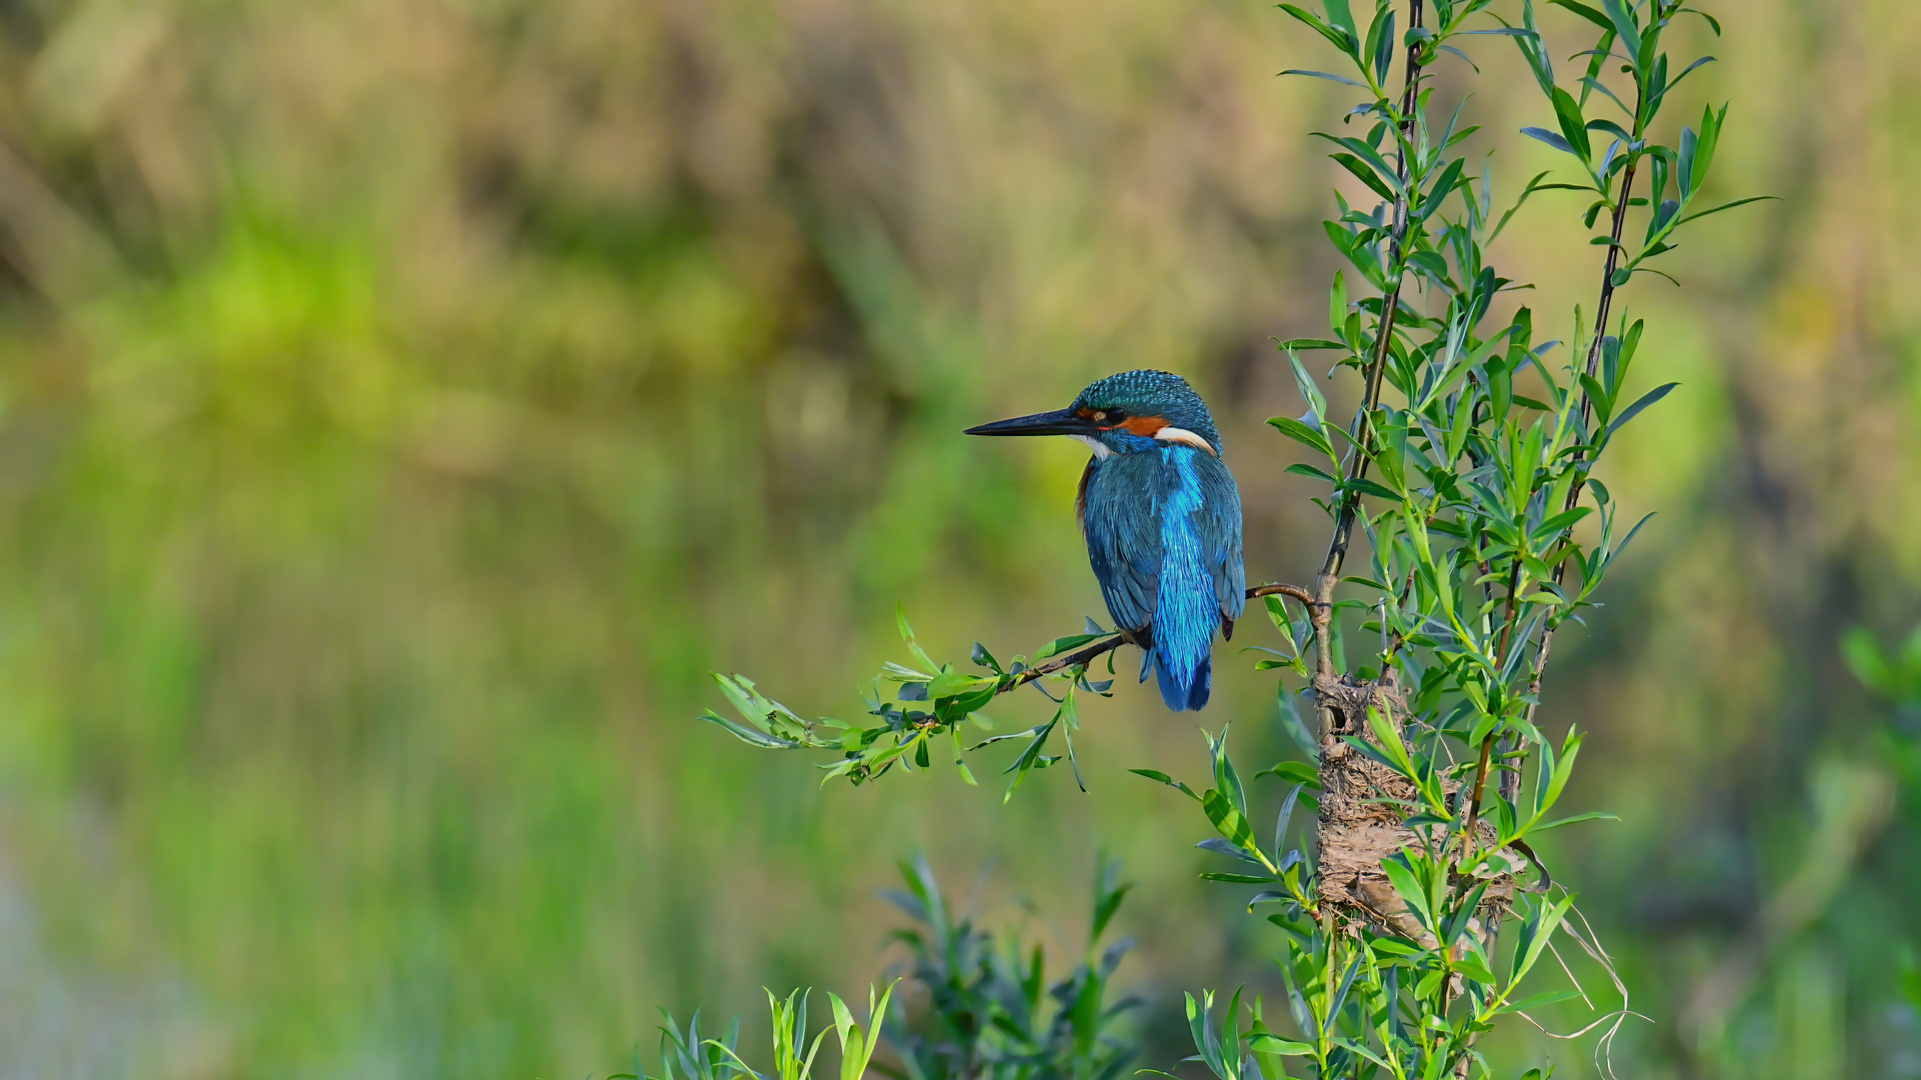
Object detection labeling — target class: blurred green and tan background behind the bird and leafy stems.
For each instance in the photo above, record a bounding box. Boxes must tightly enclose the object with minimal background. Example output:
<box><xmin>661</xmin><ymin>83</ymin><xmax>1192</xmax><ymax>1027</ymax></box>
<box><xmin>0</xmin><ymin>0</ymin><xmax>1921</xmax><ymax>1080</ymax></box>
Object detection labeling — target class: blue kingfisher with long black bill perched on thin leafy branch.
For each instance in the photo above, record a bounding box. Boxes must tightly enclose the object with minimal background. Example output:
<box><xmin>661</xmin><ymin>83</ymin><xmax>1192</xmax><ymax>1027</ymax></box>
<box><xmin>966</xmin><ymin>371</ymin><xmax>1247</xmax><ymax>713</ymax></box>
